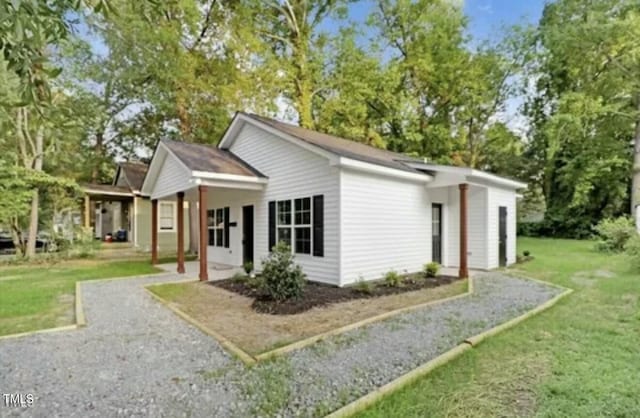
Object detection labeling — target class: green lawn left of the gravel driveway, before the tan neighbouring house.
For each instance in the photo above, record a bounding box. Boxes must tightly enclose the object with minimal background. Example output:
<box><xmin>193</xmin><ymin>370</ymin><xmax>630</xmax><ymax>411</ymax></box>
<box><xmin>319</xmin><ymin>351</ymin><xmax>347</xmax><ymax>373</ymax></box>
<box><xmin>0</xmin><ymin>260</ymin><xmax>159</xmax><ymax>335</ymax></box>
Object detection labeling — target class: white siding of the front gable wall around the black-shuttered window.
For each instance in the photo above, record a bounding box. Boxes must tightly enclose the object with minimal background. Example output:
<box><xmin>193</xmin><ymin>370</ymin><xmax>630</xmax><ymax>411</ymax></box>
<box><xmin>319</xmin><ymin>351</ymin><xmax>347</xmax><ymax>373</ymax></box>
<box><xmin>229</xmin><ymin>124</ymin><xmax>339</xmax><ymax>284</ymax></box>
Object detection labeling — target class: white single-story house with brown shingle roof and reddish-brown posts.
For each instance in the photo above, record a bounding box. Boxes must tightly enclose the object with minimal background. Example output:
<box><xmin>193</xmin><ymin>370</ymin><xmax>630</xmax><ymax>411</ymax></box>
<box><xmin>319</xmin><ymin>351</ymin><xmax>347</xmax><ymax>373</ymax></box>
<box><xmin>142</xmin><ymin>112</ymin><xmax>526</xmax><ymax>286</ymax></box>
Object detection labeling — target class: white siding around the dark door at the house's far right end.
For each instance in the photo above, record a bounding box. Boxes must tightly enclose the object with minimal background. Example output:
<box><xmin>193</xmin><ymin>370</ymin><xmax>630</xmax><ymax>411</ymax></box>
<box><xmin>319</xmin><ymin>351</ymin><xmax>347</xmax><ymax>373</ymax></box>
<box><xmin>487</xmin><ymin>187</ymin><xmax>516</xmax><ymax>268</ymax></box>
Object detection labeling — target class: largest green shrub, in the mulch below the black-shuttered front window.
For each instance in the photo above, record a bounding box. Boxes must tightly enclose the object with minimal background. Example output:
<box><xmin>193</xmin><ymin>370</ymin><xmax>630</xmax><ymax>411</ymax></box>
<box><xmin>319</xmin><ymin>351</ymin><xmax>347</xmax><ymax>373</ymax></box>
<box><xmin>262</xmin><ymin>242</ymin><xmax>305</xmax><ymax>301</ymax></box>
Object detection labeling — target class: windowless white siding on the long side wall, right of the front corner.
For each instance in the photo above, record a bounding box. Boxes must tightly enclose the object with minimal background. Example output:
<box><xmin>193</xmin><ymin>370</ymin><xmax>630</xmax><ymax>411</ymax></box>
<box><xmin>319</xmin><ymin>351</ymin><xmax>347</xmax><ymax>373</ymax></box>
<box><xmin>340</xmin><ymin>169</ymin><xmax>431</xmax><ymax>285</ymax></box>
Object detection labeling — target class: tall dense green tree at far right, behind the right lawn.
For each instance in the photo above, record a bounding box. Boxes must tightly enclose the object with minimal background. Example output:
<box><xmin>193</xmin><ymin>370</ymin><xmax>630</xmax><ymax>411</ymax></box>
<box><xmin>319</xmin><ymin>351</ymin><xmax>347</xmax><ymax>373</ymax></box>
<box><xmin>526</xmin><ymin>0</ymin><xmax>640</xmax><ymax>236</ymax></box>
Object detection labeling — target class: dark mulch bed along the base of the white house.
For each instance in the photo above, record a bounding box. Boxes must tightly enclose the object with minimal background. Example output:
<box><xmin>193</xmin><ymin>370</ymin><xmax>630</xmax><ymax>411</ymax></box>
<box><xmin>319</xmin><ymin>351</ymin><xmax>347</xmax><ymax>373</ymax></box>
<box><xmin>209</xmin><ymin>274</ymin><xmax>459</xmax><ymax>315</ymax></box>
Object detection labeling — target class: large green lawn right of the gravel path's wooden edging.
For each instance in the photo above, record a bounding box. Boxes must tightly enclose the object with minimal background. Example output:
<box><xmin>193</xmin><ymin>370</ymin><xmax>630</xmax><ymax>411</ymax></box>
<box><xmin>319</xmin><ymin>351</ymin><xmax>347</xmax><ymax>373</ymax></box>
<box><xmin>359</xmin><ymin>238</ymin><xmax>640</xmax><ymax>417</ymax></box>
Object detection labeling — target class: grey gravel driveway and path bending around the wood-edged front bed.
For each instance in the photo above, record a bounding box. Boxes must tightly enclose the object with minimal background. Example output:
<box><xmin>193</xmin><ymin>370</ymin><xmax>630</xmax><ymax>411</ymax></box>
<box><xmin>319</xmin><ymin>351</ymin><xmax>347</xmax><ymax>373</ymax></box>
<box><xmin>0</xmin><ymin>273</ymin><xmax>561</xmax><ymax>417</ymax></box>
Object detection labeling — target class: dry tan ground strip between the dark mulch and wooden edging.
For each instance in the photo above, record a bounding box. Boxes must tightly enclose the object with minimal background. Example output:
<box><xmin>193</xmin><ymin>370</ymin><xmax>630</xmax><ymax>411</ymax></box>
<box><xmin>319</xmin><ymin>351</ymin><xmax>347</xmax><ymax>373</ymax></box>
<box><xmin>149</xmin><ymin>279</ymin><xmax>467</xmax><ymax>355</ymax></box>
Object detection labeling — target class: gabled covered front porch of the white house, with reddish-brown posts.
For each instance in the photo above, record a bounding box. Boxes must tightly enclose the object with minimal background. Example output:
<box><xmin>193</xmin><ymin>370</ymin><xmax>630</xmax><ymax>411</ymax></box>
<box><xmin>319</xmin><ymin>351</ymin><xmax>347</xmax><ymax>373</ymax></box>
<box><xmin>143</xmin><ymin>141</ymin><xmax>267</xmax><ymax>281</ymax></box>
